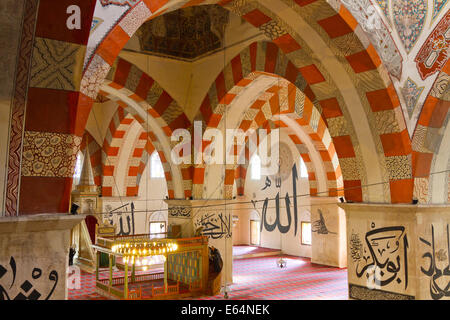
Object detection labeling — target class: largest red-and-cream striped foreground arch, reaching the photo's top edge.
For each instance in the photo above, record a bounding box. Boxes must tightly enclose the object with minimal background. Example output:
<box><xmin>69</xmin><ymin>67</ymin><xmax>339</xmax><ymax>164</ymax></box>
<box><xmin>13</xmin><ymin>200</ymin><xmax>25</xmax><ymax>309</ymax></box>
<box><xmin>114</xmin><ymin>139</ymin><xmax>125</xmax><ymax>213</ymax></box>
<box><xmin>82</xmin><ymin>0</ymin><xmax>413</xmax><ymax>203</ymax></box>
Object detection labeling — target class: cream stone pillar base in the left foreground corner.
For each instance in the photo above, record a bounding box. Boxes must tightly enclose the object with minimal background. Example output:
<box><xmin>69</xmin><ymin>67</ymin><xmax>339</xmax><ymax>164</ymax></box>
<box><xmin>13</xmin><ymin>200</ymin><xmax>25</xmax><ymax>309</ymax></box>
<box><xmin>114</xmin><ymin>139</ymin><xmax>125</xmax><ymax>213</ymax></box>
<box><xmin>0</xmin><ymin>214</ymin><xmax>84</xmax><ymax>300</ymax></box>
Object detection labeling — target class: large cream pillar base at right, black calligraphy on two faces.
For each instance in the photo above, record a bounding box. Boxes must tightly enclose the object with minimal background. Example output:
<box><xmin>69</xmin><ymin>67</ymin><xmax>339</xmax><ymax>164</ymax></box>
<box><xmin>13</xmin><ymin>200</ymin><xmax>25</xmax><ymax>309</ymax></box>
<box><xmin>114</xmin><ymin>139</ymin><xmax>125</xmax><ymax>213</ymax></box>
<box><xmin>340</xmin><ymin>204</ymin><xmax>450</xmax><ymax>300</ymax></box>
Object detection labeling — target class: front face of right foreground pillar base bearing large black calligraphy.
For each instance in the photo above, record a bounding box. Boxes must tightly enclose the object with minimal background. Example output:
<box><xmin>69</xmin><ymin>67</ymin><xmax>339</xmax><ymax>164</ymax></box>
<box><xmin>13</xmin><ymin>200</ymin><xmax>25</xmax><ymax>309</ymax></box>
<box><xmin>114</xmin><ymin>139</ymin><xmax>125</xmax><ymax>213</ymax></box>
<box><xmin>346</xmin><ymin>208</ymin><xmax>416</xmax><ymax>300</ymax></box>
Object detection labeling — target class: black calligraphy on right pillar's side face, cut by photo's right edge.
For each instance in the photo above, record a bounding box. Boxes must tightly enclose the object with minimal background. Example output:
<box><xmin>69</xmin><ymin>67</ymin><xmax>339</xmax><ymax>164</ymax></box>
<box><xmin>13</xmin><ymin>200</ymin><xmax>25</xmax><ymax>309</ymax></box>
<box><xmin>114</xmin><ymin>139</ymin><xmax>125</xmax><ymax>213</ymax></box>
<box><xmin>419</xmin><ymin>224</ymin><xmax>450</xmax><ymax>300</ymax></box>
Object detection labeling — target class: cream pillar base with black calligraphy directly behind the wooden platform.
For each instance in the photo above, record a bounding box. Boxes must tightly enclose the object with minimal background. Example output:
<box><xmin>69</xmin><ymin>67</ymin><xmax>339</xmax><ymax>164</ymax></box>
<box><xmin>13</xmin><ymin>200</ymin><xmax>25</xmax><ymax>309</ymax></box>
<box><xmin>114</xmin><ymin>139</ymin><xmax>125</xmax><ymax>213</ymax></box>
<box><xmin>165</xmin><ymin>200</ymin><xmax>233</xmax><ymax>285</ymax></box>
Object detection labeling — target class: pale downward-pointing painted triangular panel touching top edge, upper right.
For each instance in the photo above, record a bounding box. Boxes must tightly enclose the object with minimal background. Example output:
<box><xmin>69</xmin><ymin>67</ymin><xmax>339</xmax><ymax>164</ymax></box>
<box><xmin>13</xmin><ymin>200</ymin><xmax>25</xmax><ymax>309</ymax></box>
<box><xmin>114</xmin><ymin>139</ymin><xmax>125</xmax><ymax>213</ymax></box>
<box><xmin>392</xmin><ymin>0</ymin><xmax>428</xmax><ymax>52</ymax></box>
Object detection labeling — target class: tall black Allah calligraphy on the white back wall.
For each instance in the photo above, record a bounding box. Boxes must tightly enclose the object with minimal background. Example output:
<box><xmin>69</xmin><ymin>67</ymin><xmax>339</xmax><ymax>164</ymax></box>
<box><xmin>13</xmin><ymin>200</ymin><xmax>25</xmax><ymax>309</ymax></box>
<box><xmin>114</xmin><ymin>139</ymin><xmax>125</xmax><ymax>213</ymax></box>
<box><xmin>252</xmin><ymin>165</ymin><xmax>298</xmax><ymax>235</ymax></box>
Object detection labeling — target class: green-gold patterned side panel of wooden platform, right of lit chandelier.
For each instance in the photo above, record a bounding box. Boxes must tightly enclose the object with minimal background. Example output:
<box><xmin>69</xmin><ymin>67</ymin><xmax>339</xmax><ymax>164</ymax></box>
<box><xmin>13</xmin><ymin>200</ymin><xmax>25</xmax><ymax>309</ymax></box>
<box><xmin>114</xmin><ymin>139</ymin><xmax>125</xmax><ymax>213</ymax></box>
<box><xmin>167</xmin><ymin>251</ymin><xmax>201</xmax><ymax>284</ymax></box>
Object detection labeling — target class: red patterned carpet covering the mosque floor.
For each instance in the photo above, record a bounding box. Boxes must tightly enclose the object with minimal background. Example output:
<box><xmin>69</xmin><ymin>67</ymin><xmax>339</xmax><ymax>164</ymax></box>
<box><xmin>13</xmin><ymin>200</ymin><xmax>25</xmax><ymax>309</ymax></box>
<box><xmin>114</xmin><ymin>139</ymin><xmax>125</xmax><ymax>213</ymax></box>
<box><xmin>69</xmin><ymin>255</ymin><xmax>348</xmax><ymax>300</ymax></box>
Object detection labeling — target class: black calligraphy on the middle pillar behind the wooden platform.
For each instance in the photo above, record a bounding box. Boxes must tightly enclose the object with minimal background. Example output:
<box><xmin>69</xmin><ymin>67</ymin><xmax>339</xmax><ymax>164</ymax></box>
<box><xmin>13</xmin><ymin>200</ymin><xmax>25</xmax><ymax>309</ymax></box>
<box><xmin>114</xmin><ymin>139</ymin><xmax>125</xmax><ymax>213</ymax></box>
<box><xmin>195</xmin><ymin>212</ymin><xmax>232</xmax><ymax>239</ymax></box>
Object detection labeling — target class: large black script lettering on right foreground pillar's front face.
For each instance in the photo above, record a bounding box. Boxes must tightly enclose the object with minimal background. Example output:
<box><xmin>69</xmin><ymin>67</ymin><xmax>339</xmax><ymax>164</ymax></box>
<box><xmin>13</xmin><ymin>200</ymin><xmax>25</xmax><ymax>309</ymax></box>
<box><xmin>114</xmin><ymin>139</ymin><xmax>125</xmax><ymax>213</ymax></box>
<box><xmin>351</xmin><ymin>223</ymin><xmax>408</xmax><ymax>289</ymax></box>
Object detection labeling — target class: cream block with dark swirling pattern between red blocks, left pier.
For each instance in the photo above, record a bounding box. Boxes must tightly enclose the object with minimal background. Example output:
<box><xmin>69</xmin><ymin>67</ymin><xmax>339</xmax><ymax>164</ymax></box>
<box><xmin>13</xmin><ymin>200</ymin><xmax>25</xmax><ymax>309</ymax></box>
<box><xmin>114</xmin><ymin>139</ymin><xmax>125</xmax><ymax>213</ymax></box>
<box><xmin>22</xmin><ymin>131</ymin><xmax>81</xmax><ymax>177</ymax></box>
